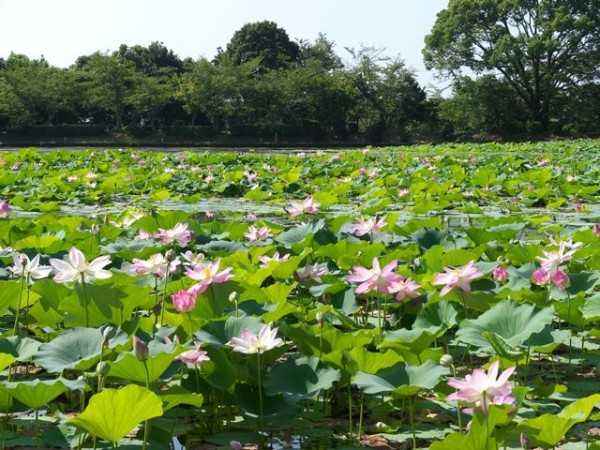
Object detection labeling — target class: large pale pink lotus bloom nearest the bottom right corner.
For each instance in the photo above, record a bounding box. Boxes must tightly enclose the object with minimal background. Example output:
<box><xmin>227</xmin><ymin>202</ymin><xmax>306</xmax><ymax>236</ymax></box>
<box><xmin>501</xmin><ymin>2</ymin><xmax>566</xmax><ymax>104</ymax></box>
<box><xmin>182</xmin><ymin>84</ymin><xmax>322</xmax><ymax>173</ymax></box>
<box><xmin>446</xmin><ymin>361</ymin><xmax>515</xmax><ymax>414</ymax></box>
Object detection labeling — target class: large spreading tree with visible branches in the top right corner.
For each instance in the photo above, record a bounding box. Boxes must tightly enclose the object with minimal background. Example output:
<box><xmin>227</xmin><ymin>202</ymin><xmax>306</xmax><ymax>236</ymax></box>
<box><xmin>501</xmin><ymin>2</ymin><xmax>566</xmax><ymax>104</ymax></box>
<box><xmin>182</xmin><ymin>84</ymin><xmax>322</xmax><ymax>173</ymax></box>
<box><xmin>423</xmin><ymin>0</ymin><xmax>600</xmax><ymax>127</ymax></box>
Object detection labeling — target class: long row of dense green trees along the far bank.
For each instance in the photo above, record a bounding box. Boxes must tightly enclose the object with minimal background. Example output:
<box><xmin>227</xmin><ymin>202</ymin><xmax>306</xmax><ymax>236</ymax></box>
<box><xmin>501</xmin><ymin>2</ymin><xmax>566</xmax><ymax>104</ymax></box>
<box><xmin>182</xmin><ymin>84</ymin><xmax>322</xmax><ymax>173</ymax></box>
<box><xmin>0</xmin><ymin>17</ymin><xmax>600</xmax><ymax>143</ymax></box>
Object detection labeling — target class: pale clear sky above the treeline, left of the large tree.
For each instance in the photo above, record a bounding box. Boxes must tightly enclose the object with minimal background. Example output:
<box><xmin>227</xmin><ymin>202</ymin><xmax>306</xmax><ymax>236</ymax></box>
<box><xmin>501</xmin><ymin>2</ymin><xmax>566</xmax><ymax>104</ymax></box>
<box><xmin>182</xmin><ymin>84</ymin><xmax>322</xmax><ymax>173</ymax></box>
<box><xmin>0</xmin><ymin>0</ymin><xmax>448</xmax><ymax>86</ymax></box>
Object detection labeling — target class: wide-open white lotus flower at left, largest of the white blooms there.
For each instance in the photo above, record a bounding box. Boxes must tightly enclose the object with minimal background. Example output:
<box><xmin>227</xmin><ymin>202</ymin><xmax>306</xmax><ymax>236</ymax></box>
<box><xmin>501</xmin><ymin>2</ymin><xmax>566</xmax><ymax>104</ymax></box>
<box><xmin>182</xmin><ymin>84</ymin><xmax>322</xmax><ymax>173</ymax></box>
<box><xmin>49</xmin><ymin>247</ymin><xmax>112</xmax><ymax>283</ymax></box>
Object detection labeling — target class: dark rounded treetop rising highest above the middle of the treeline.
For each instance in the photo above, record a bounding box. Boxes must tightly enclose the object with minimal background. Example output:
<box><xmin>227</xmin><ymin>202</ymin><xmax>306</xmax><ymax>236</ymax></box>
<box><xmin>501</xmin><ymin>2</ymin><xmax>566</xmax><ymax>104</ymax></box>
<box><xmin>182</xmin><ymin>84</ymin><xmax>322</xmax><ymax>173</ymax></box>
<box><xmin>215</xmin><ymin>21</ymin><xmax>300</xmax><ymax>72</ymax></box>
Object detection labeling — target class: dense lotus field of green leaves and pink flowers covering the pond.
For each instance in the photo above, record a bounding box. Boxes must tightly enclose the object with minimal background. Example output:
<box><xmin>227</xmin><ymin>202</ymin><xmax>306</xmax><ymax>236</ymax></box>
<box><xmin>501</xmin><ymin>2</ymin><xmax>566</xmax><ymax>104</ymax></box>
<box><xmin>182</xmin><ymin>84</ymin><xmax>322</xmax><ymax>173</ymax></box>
<box><xmin>0</xmin><ymin>141</ymin><xmax>600</xmax><ymax>450</ymax></box>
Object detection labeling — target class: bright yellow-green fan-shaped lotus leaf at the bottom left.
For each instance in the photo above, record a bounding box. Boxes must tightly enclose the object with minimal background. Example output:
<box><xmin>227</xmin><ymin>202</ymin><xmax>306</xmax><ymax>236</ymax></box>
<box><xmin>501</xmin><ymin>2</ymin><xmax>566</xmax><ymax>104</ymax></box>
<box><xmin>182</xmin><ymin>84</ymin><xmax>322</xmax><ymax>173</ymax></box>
<box><xmin>68</xmin><ymin>384</ymin><xmax>163</xmax><ymax>442</ymax></box>
